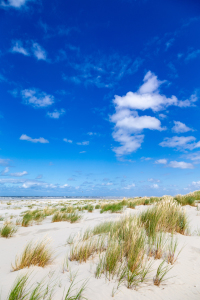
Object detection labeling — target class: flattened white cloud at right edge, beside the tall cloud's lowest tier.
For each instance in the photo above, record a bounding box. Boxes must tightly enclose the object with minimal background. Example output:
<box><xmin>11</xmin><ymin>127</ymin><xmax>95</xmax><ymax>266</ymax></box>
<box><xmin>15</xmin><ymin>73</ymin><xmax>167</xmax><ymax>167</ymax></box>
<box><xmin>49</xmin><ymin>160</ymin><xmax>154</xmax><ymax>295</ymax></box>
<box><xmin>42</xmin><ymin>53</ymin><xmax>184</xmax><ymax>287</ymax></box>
<box><xmin>159</xmin><ymin>136</ymin><xmax>200</xmax><ymax>150</ymax></box>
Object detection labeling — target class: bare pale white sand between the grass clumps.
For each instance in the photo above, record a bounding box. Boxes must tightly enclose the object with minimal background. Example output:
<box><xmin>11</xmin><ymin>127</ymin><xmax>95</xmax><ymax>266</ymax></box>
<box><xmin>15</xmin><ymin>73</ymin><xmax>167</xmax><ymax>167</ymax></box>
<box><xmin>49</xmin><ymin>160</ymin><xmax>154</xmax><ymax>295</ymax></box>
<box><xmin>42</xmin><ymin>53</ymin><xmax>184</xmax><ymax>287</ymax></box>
<box><xmin>0</xmin><ymin>199</ymin><xmax>200</xmax><ymax>300</ymax></box>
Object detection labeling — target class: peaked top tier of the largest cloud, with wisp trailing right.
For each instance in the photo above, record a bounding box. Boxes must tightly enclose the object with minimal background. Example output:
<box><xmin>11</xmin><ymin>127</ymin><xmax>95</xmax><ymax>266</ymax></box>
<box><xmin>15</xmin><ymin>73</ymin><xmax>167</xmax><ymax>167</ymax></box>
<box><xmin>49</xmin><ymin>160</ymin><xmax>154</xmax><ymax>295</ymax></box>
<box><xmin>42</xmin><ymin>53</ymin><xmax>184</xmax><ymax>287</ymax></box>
<box><xmin>113</xmin><ymin>71</ymin><xmax>197</xmax><ymax>111</ymax></box>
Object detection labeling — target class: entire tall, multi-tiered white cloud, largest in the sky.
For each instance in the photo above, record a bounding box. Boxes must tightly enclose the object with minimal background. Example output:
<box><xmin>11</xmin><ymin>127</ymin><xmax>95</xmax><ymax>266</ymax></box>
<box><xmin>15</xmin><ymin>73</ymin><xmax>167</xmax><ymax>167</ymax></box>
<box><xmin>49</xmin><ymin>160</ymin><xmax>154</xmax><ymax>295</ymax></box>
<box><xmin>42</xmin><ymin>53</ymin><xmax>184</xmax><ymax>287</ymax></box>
<box><xmin>110</xmin><ymin>71</ymin><xmax>197</xmax><ymax>157</ymax></box>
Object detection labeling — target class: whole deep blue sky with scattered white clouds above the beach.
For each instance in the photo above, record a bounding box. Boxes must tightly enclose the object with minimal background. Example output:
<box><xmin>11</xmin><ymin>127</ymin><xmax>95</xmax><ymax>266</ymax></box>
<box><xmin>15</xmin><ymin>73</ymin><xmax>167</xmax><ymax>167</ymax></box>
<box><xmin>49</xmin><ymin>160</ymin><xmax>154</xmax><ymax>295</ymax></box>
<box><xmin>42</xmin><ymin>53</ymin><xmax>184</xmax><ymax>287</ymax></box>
<box><xmin>0</xmin><ymin>0</ymin><xmax>200</xmax><ymax>197</ymax></box>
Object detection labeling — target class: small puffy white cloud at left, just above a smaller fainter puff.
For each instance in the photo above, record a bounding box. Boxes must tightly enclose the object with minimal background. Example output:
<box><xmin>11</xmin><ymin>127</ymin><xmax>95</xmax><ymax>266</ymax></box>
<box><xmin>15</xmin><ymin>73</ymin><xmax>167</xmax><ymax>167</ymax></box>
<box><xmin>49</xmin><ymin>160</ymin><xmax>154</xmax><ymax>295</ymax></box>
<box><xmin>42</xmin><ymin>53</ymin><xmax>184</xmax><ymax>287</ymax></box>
<box><xmin>21</xmin><ymin>89</ymin><xmax>54</xmax><ymax>107</ymax></box>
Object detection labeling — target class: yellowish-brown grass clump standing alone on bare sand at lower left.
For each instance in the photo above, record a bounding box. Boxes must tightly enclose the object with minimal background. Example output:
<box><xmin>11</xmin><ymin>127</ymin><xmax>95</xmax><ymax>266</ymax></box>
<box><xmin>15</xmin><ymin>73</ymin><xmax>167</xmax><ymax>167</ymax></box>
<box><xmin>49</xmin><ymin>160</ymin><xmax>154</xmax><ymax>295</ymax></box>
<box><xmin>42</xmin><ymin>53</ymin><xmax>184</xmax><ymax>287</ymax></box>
<box><xmin>12</xmin><ymin>239</ymin><xmax>54</xmax><ymax>271</ymax></box>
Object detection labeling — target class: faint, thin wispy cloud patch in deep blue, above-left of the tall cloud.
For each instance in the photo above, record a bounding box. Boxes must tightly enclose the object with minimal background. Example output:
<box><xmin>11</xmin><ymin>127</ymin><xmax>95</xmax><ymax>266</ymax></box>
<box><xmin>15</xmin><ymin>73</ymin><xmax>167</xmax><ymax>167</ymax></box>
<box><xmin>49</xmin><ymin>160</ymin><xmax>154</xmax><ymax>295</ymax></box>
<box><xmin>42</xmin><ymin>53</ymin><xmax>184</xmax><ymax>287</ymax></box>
<box><xmin>63</xmin><ymin>52</ymin><xmax>143</xmax><ymax>88</ymax></box>
